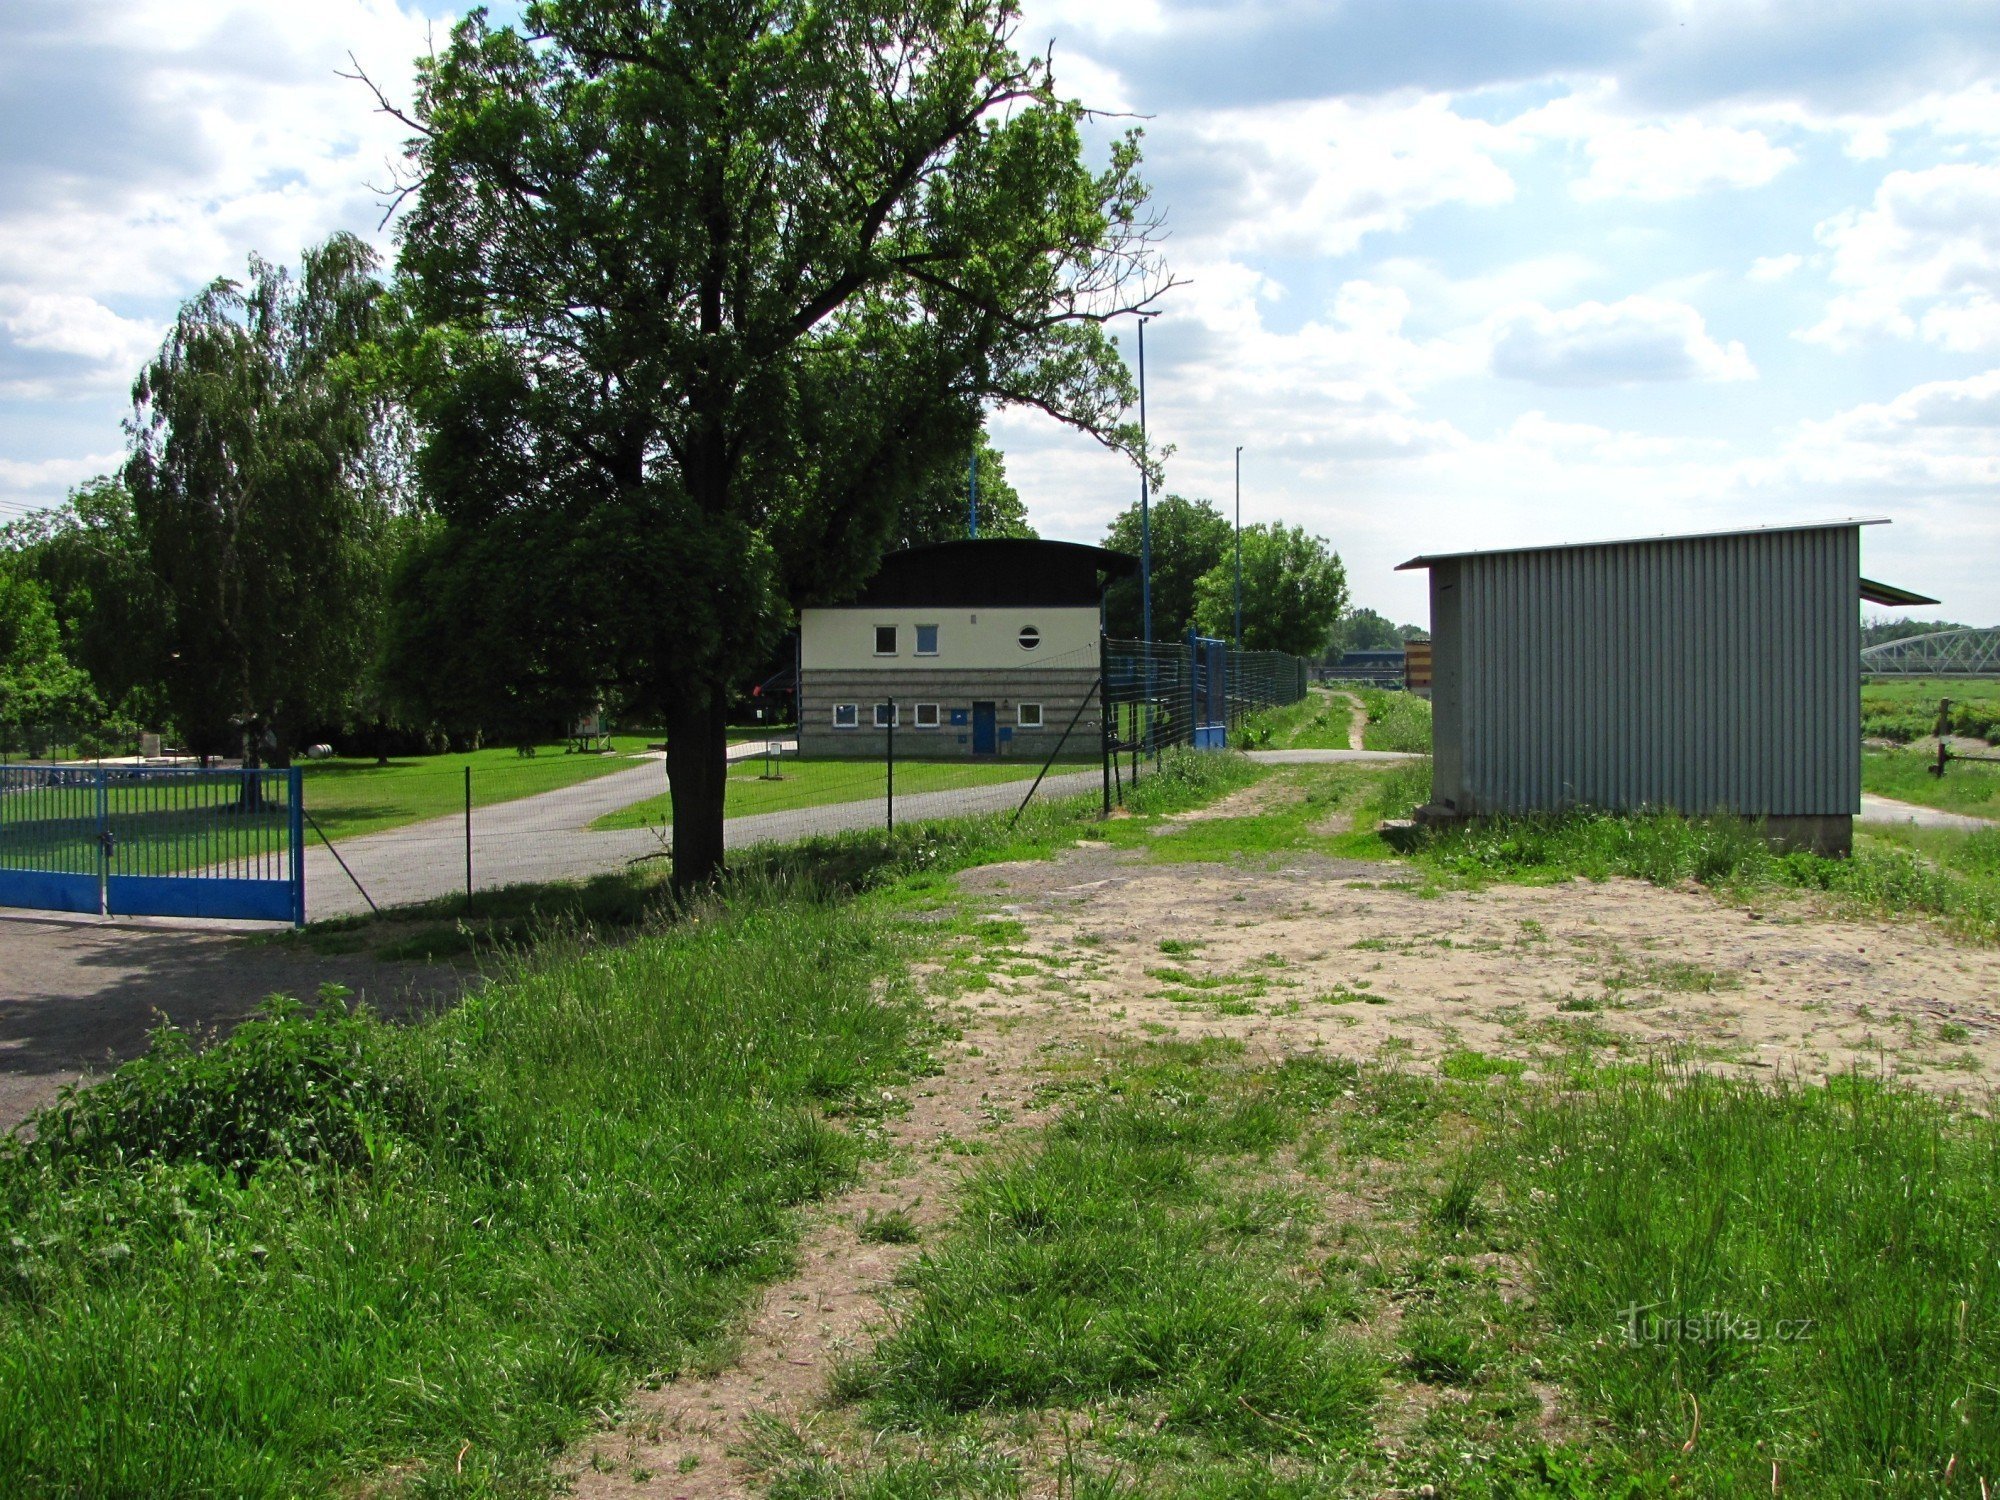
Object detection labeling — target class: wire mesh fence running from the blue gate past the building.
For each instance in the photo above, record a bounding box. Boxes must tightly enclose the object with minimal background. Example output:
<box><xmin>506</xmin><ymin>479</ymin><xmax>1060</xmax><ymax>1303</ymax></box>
<box><xmin>3</xmin><ymin>640</ymin><xmax>1308</xmax><ymax>918</ymax></box>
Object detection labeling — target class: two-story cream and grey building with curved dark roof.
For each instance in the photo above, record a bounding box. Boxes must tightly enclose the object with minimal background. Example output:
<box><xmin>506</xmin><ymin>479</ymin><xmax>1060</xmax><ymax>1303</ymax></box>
<box><xmin>798</xmin><ymin>538</ymin><xmax>1138</xmax><ymax>760</ymax></box>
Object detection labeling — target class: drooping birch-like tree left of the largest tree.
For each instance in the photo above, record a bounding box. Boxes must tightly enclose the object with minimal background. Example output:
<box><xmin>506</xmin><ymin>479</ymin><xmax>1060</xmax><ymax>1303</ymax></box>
<box><xmin>124</xmin><ymin>234</ymin><xmax>402</xmax><ymax>760</ymax></box>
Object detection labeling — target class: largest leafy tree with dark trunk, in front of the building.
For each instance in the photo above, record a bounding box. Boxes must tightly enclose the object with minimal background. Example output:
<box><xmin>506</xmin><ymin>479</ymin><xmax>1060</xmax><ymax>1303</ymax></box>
<box><xmin>380</xmin><ymin>0</ymin><xmax>1158</xmax><ymax>882</ymax></box>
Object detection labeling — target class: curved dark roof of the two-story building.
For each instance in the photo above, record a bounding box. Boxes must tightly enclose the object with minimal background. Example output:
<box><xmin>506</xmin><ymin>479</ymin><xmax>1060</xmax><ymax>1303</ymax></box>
<box><xmin>854</xmin><ymin>536</ymin><xmax>1138</xmax><ymax>608</ymax></box>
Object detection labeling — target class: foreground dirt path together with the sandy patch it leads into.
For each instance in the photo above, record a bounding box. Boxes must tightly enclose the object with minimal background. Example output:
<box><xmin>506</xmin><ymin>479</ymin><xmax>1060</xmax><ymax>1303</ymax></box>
<box><xmin>556</xmin><ymin>780</ymin><xmax>2000</xmax><ymax>1500</ymax></box>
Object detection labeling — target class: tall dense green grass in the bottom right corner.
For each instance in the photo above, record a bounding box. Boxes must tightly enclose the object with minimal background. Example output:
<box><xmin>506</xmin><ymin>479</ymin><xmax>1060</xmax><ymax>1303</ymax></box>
<box><xmin>1494</xmin><ymin>1076</ymin><xmax>2000</xmax><ymax>1496</ymax></box>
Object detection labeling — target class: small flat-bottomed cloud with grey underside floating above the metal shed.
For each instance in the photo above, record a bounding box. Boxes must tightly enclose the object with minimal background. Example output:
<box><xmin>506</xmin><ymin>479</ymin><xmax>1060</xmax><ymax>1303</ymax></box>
<box><xmin>1492</xmin><ymin>296</ymin><xmax>1756</xmax><ymax>386</ymax></box>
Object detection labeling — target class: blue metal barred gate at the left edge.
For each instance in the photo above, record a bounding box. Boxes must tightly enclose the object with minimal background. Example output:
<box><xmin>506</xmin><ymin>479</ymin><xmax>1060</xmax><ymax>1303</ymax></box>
<box><xmin>0</xmin><ymin>766</ymin><xmax>306</xmax><ymax>926</ymax></box>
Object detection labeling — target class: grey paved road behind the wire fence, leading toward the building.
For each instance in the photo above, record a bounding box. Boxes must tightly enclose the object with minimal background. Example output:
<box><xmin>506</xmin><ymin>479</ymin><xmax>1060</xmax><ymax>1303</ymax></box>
<box><xmin>306</xmin><ymin>756</ymin><xmax>1102</xmax><ymax>920</ymax></box>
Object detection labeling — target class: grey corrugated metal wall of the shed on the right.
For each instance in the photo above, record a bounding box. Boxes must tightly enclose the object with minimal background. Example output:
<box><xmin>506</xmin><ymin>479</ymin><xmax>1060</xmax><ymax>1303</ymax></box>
<box><xmin>1430</xmin><ymin>526</ymin><xmax>1860</xmax><ymax>816</ymax></box>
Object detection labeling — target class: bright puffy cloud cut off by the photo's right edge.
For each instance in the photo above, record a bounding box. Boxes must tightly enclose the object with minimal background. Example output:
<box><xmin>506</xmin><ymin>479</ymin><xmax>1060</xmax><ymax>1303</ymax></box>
<box><xmin>1802</xmin><ymin>164</ymin><xmax>2000</xmax><ymax>352</ymax></box>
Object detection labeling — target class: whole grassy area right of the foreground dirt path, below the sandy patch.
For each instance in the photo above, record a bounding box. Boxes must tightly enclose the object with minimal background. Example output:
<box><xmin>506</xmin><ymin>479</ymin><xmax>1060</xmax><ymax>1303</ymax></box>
<box><xmin>762</xmin><ymin>1042</ymin><xmax>2000</xmax><ymax>1500</ymax></box>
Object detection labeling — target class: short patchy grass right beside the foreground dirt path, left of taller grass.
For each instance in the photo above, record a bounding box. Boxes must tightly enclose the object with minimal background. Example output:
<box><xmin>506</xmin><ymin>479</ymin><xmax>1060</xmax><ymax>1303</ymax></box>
<box><xmin>820</xmin><ymin>1044</ymin><xmax>1374</xmax><ymax>1472</ymax></box>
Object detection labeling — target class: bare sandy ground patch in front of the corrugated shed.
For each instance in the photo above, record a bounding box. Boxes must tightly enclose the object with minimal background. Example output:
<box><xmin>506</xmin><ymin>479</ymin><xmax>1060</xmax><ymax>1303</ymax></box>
<box><xmin>964</xmin><ymin>848</ymin><xmax>2000</xmax><ymax>1094</ymax></box>
